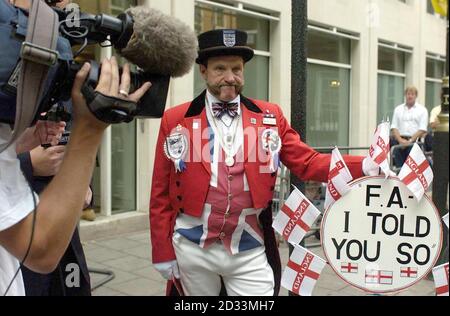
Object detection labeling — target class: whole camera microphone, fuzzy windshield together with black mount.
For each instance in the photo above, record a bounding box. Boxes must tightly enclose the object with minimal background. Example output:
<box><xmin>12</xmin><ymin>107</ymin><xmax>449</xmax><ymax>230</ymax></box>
<box><xmin>55</xmin><ymin>6</ymin><xmax>198</xmax><ymax>77</ymax></box>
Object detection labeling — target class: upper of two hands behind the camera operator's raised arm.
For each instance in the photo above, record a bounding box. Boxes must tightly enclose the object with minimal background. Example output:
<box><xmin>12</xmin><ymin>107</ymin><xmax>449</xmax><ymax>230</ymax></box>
<box><xmin>16</xmin><ymin>121</ymin><xmax>66</xmax><ymax>154</ymax></box>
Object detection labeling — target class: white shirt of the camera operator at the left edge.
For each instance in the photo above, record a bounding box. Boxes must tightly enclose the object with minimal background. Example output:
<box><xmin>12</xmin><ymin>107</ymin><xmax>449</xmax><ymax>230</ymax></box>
<box><xmin>0</xmin><ymin>123</ymin><xmax>38</xmax><ymax>296</ymax></box>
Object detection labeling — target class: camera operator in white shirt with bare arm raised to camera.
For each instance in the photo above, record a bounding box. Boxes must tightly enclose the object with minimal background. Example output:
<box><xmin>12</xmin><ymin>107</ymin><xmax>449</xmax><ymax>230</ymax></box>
<box><xmin>0</xmin><ymin>0</ymin><xmax>151</xmax><ymax>295</ymax></box>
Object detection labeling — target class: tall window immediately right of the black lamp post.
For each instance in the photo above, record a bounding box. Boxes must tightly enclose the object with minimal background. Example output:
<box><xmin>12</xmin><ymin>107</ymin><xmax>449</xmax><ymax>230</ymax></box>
<box><xmin>306</xmin><ymin>28</ymin><xmax>351</xmax><ymax>147</ymax></box>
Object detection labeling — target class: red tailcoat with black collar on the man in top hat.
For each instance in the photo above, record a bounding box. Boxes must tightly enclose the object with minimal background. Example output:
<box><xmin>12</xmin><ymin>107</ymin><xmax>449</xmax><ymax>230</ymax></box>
<box><xmin>150</xmin><ymin>91</ymin><xmax>363</xmax><ymax>293</ymax></box>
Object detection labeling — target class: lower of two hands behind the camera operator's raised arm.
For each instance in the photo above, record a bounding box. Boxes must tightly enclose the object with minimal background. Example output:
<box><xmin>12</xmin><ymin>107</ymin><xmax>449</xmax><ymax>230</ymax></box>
<box><xmin>30</xmin><ymin>146</ymin><xmax>66</xmax><ymax>177</ymax></box>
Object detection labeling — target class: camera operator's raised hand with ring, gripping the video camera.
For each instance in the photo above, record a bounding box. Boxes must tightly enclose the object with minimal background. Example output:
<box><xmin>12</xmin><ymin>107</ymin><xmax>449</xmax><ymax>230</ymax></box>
<box><xmin>72</xmin><ymin>57</ymin><xmax>151</xmax><ymax>131</ymax></box>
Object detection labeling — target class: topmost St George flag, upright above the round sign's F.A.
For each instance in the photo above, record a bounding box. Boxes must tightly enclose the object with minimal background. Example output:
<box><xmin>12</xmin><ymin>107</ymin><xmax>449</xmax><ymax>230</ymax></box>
<box><xmin>369</xmin><ymin>122</ymin><xmax>391</xmax><ymax>177</ymax></box>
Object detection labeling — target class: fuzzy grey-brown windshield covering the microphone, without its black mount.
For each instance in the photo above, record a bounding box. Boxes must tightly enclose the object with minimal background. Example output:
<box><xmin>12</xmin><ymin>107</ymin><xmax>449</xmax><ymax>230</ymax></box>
<box><xmin>119</xmin><ymin>6</ymin><xmax>198</xmax><ymax>77</ymax></box>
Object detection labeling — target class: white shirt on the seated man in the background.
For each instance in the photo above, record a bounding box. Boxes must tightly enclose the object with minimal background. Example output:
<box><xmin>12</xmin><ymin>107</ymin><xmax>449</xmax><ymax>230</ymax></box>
<box><xmin>391</xmin><ymin>103</ymin><xmax>428</xmax><ymax>137</ymax></box>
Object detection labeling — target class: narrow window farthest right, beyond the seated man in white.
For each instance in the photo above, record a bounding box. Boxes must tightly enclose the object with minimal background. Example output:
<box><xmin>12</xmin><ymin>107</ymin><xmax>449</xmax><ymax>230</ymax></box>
<box><xmin>425</xmin><ymin>55</ymin><xmax>445</xmax><ymax>112</ymax></box>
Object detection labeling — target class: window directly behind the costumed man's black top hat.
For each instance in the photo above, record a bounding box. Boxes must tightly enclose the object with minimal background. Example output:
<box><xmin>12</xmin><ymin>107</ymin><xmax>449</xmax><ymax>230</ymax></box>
<box><xmin>194</xmin><ymin>1</ymin><xmax>270</xmax><ymax>100</ymax></box>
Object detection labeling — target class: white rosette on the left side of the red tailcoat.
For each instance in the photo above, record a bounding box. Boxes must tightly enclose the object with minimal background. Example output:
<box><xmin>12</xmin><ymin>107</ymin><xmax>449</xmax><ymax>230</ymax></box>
<box><xmin>164</xmin><ymin>126</ymin><xmax>189</xmax><ymax>172</ymax></box>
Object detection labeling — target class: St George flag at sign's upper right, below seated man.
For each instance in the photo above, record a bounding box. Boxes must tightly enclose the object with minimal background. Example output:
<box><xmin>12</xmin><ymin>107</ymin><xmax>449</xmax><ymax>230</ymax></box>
<box><xmin>398</xmin><ymin>144</ymin><xmax>433</xmax><ymax>202</ymax></box>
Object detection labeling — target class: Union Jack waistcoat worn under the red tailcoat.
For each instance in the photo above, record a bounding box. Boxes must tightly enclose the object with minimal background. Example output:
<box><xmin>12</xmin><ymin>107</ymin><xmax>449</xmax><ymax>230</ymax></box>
<box><xmin>175</xmin><ymin>141</ymin><xmax>264</xmax><ymax>254</ymax></box>
